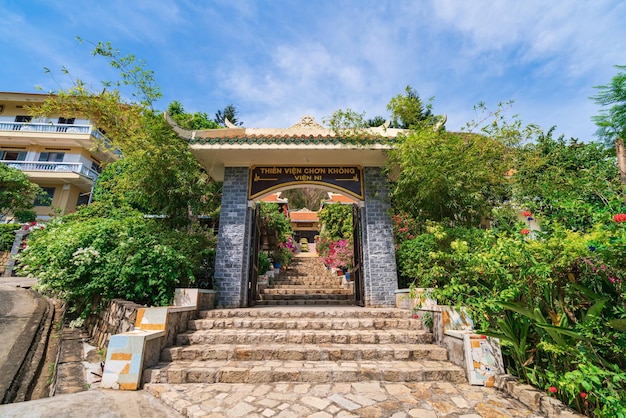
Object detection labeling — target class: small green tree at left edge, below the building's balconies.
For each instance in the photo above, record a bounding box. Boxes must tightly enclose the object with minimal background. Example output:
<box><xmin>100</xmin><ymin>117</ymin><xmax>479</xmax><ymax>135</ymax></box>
<box><xmin>0</xmin><ymin>164</ymin><xmax>47</xmax><ymax>220</ymax></box>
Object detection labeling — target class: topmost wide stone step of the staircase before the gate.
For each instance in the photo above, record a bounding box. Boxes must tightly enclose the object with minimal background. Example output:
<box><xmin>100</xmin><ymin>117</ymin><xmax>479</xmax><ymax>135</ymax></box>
<box><xmin>198</xmin><ymin>306</ymin><xmax>418</xmax><ymax>322</ymax></box>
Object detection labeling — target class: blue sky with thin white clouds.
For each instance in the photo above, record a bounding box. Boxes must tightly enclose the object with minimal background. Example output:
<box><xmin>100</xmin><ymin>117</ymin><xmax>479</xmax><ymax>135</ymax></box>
<box><xmin>0</xmin><ymin>0</ymin><xmax>626</xmax><ymax>141</ymax></box>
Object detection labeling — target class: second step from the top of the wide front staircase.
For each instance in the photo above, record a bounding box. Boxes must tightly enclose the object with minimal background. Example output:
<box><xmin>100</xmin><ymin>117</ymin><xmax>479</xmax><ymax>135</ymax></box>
<box><xmin>188</xmin><ymin>317</ymin><xmax>422</xmax><ymax>331</ymax></box>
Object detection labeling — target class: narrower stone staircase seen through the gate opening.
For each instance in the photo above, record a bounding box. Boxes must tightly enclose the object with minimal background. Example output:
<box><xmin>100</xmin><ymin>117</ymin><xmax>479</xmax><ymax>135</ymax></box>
<box><xmin>256</xmin><ymin>253</ymin><xmax>354</xmax><ymax>306</ymax></box>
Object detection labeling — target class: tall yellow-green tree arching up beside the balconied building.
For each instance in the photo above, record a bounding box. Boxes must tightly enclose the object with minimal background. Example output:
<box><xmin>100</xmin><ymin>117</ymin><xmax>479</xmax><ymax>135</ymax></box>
<box><xmin>31</xmin><ymin>42</ymin><xmax>220</xmax><ymax>226</ymax></box>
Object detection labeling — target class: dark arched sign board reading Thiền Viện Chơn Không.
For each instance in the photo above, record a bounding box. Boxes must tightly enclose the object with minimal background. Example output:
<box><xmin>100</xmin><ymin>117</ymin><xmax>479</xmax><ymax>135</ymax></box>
<box><xmin>248</xmin><ymin>165</ymin><xmax>363</xmax><ymax>200</ymax></box>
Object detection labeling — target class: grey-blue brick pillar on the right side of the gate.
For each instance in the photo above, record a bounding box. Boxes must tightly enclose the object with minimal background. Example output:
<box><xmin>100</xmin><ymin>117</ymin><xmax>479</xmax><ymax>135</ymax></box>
<box><xmin>361</xmin><ymin>167</ymin><xmax>398</xmax><ymax>307</ymax></box>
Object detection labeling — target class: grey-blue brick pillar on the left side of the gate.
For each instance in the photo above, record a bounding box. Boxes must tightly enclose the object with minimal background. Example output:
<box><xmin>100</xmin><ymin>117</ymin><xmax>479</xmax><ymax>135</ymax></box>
<box><xmin>213</xmin><ymin>167</ymin><xmax>250</xmax><ymax>308</ymax></box>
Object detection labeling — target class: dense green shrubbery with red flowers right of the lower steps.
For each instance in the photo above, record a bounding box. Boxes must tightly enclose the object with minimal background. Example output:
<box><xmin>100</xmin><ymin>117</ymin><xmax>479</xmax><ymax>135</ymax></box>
<box><xmin>398</xmin><ymin>223</ymin><xmax>626</xmax><ymax>417</ymax></box>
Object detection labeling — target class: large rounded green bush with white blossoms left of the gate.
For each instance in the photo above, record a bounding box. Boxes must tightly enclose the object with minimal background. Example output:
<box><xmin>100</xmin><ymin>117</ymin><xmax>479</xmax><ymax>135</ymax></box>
<box><xmin>19</xmin><ymin>204</ymin><xmax>212</xmax><ymax>316</ymax></box>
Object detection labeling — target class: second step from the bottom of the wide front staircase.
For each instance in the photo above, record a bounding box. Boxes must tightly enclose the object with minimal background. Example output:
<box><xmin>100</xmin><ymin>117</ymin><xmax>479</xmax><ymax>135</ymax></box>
<box><xmin>161</xmin><ymin>344</ymin><xmax>448</xmax><ymax>361</ymax></box>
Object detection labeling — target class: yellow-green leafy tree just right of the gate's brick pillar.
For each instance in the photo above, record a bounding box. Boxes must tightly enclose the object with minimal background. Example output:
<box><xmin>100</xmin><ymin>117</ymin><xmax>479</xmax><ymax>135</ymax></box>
<box><xmin>390</xmin><ymin>128</ymin><xmax>511</xmax><ymax>226</ymax></box>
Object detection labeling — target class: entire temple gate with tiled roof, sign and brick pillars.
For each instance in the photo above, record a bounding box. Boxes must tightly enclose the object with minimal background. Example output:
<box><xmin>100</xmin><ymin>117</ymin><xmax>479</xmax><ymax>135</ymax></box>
<box><xmin>168</xmin><ymin>116</ymin><xmax>401</xmax><ymax>308</ymax></box>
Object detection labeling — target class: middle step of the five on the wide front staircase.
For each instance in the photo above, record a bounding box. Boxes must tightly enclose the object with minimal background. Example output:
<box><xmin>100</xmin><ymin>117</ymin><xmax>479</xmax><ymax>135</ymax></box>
<box><xmin>176</xmin><ymin>329</ymin><xmax>433</xmax><ymax>345</ymax></box>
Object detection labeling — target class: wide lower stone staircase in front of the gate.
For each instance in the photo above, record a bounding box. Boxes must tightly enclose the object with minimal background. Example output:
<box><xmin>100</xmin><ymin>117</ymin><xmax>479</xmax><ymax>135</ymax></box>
<box><xmin>143</xmin><ymin>306</ymin><xmax>466</xmax><ymax>384</ymax></box>
